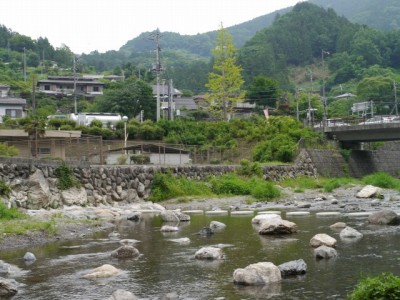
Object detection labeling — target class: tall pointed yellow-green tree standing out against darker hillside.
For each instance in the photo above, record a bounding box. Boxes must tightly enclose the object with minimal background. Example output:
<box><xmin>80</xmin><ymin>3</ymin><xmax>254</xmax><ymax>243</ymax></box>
<box><xmin>206</xmin><ymin>24</ymin><xmax>244</xmax><ymax>120</ymax></box>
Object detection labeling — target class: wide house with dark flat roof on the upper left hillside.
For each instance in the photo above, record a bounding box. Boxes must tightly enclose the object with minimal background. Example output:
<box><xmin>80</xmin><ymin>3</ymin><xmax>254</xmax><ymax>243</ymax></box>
<box><xmin>38</xmin><ymin>76</ymin><xmax>105</xmax><ymax>99</ymax></box>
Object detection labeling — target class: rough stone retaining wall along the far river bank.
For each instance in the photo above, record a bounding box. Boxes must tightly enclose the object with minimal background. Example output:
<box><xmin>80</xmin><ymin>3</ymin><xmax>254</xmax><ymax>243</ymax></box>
<box><xmin>0</xmin><ymin>151</ymin><xmax>317</xmax><ymax>209</ymax></box>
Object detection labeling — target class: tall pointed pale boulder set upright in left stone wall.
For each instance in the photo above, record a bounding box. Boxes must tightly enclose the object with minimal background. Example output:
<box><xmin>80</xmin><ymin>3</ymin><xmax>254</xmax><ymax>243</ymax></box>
<box><xmin>27</xmin><ymin>169</ymin><xmax>51</xmax><ymax>209</ymax></box>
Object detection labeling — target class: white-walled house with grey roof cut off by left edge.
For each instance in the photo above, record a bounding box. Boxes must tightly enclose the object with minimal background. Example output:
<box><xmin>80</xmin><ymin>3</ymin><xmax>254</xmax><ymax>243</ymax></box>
<box><xmin>0</xmin><ymin>84</ymin><xmax>26</xmax><ymax>123</ymax></box>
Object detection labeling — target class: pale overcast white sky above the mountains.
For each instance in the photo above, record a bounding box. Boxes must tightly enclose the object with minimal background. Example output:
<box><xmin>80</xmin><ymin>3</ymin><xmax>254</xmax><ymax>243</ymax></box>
<box><xmin>0</xmin><ymin>0</ymin><xmax>300</xmax><ymax>54</ymax></box>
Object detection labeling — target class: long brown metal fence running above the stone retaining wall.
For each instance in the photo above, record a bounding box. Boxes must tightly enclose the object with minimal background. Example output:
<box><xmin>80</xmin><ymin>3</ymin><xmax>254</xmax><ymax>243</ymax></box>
<box><xmin>0</xmin><ymin>135</ymin><xmax>251</xmax><ymax>165</ymax></box>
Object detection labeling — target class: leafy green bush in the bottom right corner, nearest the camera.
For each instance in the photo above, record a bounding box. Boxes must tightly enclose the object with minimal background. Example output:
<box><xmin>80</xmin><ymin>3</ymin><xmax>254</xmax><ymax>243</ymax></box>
<box><xmin>348</xmin><ymin>273</ymin><xmax>400</xmax><ymax>300</ymax></box>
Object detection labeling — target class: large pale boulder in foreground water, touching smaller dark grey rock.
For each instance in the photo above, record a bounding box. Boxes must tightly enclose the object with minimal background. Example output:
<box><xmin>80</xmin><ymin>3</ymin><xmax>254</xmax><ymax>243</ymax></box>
<box><xmin>233</xmin><ymin>262</ymin><xmax>282</xmax><ymax>285</ymax></box>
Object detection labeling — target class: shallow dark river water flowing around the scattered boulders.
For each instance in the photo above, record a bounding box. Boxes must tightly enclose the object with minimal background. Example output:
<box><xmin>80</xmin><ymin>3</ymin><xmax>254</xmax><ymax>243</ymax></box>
<box><xmin>1</xmin><ymin>212</ymin><xmax>400</xmax><ymax>300</ymax></box>
